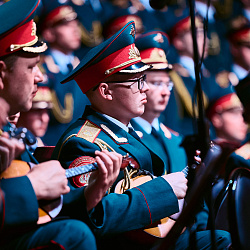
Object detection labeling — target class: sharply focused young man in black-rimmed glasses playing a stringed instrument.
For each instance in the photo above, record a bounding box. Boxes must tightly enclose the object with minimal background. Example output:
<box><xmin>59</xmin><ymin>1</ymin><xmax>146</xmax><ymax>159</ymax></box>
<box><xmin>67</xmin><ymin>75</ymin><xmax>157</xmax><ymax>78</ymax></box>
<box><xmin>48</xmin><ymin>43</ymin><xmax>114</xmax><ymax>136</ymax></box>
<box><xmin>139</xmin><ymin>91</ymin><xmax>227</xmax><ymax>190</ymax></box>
<box><xmin>53</xmin><ymin>21</ymin><xmax>230</xmax><ymax>249</ymax></box>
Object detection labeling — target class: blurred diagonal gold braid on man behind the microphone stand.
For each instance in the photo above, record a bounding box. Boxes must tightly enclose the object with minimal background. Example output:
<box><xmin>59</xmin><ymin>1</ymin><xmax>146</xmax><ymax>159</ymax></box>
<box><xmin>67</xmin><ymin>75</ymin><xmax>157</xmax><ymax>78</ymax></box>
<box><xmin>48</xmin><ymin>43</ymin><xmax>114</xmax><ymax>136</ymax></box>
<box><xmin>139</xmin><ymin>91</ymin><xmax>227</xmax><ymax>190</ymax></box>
<box><xmin>169</xmin><ymin>70</ymin><xmax>208</xmax><ymax>117</ymax></box>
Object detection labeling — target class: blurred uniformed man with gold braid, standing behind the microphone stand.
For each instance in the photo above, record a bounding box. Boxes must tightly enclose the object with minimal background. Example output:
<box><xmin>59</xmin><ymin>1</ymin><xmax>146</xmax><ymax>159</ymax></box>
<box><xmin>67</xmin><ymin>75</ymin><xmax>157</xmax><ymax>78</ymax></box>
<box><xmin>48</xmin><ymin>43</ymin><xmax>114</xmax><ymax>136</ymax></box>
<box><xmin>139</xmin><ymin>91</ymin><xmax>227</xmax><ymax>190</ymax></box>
<box><xmin>162</xmin><ymin>9</ymin><xmax>230</xmax><ymax>136</ymax></box>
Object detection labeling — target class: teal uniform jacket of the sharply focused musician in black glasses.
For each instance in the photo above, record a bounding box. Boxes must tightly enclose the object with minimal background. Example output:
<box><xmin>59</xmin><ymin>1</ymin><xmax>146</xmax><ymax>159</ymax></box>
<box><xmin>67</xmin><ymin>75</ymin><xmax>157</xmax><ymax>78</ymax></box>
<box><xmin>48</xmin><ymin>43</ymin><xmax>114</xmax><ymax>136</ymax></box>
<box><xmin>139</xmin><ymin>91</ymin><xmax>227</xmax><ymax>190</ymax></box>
<box><xmin>53</xmin><ymin>106</ymin><xmax>178</xmax><ymax>236</ymax></box>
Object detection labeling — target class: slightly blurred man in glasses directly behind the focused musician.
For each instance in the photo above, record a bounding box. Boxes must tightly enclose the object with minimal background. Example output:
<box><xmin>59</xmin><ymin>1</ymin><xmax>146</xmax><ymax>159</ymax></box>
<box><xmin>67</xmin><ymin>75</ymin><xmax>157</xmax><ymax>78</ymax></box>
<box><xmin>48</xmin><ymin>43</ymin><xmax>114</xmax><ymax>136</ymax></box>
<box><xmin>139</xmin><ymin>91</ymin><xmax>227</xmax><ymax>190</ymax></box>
<box><xmin>131</xmin><ymin>31</ymin><xmax>187</xmax><ymax>173</ymax></box>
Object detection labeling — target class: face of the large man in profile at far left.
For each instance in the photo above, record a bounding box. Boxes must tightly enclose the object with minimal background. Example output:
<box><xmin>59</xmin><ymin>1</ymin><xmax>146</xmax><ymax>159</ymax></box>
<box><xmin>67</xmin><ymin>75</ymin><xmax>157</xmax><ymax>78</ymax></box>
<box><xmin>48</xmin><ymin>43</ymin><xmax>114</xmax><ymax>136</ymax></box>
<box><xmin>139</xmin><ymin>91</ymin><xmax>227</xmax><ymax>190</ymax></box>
<box><xmin>1</xmin><ymin>53</ymin><xmax>43</xmax><ymax>115</ymax></box>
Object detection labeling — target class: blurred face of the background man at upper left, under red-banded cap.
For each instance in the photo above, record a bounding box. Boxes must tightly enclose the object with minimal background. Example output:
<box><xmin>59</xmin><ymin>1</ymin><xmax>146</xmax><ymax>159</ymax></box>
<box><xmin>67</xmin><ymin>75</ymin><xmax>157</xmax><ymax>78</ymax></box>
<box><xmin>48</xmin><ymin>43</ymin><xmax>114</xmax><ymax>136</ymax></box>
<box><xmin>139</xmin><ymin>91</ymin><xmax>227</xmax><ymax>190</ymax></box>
<box><xmin>51</xmin><ymin>20</ymin><xmax>81</xmax><ymax>53</ymax></box>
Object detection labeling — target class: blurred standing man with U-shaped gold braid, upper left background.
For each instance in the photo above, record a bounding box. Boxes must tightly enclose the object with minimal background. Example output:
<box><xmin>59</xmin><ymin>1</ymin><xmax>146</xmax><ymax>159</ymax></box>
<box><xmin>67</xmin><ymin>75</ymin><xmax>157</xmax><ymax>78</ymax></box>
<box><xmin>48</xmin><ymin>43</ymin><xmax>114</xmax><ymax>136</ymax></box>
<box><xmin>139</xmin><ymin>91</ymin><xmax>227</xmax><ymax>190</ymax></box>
<box><xmin>40</xmin><ymin>1</ymin><xmax>90</xmax><ymax>146</ymax></box>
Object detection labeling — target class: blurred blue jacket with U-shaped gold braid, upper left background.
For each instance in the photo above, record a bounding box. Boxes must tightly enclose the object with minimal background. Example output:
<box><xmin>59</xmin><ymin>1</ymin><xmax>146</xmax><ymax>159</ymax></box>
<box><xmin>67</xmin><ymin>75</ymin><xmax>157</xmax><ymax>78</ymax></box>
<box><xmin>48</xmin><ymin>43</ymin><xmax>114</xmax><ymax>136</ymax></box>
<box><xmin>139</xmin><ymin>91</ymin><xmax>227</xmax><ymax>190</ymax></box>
<box><xmin>42</xmin><ymin>50</ymin><xmax>91</xmax><ymax>146</ymax></box>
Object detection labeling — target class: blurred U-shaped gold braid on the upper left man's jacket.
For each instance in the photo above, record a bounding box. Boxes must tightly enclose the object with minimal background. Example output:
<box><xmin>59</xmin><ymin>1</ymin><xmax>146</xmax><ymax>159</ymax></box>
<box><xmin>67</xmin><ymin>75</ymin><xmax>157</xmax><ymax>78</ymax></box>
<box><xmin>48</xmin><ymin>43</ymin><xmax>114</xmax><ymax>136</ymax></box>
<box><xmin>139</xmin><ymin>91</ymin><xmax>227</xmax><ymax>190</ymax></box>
<box><xmin>51</xmin><ymin>91</ymin><xmax>74</xmax><ymax>123</ymax></box>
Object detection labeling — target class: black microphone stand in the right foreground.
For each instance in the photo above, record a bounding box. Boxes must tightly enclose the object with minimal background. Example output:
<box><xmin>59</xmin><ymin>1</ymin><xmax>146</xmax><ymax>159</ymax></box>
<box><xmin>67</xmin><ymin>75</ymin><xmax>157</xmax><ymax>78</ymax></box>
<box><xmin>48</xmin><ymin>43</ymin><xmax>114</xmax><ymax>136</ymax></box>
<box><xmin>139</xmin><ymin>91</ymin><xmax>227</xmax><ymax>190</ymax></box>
<box><xmin>153</xmin><ymin>0</ymin><xmax>220</xmax><ymax>247</ymax></box>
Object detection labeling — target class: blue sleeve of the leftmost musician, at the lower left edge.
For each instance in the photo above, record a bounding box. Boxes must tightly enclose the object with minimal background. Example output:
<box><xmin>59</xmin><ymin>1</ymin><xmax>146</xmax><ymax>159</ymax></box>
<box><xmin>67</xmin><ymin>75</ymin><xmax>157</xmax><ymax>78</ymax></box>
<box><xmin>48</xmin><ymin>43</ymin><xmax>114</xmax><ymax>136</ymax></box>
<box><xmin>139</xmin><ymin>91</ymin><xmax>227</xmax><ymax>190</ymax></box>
<box><xmin>0</xmin><ymin>176</ymin><xmax>38</xmax><ymax>230</ymax></box>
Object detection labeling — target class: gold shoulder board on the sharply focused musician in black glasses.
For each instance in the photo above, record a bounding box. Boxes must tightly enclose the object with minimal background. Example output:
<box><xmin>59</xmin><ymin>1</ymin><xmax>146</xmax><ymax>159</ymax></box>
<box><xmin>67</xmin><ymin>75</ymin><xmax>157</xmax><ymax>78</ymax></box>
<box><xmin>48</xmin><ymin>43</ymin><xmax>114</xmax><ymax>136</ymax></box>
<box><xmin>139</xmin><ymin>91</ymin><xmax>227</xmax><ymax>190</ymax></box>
<box><xmin>76</xmin><ymin>120</ymin><xmax>101</xmax><ymax>143</ymax></box>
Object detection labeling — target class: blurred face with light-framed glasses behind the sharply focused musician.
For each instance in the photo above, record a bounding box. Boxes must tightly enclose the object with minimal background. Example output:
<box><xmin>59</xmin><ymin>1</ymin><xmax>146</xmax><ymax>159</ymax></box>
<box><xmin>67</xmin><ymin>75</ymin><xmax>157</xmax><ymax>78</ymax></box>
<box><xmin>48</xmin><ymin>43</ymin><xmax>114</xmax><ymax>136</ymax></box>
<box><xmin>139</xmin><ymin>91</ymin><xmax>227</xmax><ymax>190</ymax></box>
<box><xmin>145</xmin><ymin>70</ymin><xmax>172</xmax><ymax>117</ymax></box>
